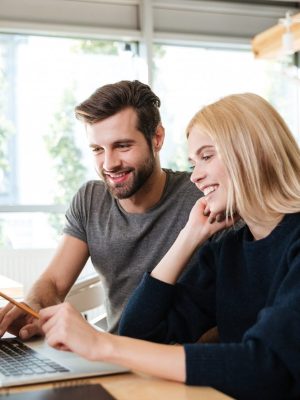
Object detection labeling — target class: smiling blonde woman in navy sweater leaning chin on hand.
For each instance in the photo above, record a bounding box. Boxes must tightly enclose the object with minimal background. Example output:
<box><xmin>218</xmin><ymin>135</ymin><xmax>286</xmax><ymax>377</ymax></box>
<box><xmin>41</xmin><ymin>93</ymin><xmax>300</xmax><ymax>399</ymax></box>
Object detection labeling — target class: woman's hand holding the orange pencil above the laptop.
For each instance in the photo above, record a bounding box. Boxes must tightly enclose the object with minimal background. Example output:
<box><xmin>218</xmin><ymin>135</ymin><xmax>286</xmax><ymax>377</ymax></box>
<box><xmin>40</xmin><ymin>303</ymin><xmax>109</xmax><ymax>360</ymax></box>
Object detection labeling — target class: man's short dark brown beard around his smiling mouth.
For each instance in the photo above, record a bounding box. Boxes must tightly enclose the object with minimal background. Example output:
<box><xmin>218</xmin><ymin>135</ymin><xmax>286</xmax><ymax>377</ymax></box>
<box><xmin>101</xmin><ymin>153</ymin><xmax>155</xmax><ymax>199</ymax></box>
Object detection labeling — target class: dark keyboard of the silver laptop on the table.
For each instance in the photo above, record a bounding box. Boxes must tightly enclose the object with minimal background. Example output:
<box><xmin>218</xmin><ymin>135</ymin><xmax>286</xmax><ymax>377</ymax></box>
<box><xmin>0</xmin><ymin>339</ymin><xmax>69</xmax><ymax>376</ymax></box>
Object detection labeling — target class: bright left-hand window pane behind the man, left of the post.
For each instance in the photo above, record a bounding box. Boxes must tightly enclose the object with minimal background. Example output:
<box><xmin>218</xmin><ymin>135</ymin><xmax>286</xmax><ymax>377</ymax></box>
<box><xmin>0</xmin><ymin>34</ymin><xmax>140</xmax><ymax>248</ymax></box>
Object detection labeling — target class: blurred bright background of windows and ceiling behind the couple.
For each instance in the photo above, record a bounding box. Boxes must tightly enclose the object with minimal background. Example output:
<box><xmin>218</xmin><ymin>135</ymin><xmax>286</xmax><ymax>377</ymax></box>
<box><xmin>0</xmin><ymin>0</ymin><xmax>300</xmax><ymax>294</ymax></box>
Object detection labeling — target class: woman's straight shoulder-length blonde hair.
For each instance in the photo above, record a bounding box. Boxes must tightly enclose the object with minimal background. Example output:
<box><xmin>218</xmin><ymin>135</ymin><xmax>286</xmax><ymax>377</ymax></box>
<box><xmin>187</xmin><ymin>93</ymin><xmax>300</xmax><ymax>223</ymax></box>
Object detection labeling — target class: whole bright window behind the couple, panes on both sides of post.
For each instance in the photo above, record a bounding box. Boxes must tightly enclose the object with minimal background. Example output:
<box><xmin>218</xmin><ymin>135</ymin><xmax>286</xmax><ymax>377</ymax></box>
<box><xmin>0</xmin><ymin>34</ymin><xmax>300</xmax><ymax>248</ymax></box>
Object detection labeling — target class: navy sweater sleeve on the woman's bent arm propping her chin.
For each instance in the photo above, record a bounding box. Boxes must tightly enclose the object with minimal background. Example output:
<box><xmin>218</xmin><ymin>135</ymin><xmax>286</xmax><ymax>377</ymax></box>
<box><xmin>119</xmin><ymin>242</ymin><xmax>216</xmax><ymax>343</ymax></box>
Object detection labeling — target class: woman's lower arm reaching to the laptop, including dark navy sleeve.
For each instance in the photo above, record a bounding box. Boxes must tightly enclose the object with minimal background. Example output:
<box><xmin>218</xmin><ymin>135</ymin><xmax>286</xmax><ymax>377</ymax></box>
<box><xmin>40</xmin><ymin>303</ymin><xmax>299</xmax><ymax>400</ymax></box>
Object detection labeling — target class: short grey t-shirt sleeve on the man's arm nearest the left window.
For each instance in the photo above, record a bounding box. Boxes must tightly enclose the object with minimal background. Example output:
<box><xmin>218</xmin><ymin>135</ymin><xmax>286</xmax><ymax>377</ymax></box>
<box><xmin>63</xmin><ymin>184</ymin><xmax>88</xmax><ymax>242</ymax></box>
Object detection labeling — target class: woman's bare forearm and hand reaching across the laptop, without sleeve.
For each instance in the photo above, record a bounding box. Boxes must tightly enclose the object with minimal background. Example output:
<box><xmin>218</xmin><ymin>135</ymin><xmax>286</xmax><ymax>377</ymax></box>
<box><xmin>40</xmin><ymin>303</ymin><xmax>185</xmax><ymax>382</ymax></box>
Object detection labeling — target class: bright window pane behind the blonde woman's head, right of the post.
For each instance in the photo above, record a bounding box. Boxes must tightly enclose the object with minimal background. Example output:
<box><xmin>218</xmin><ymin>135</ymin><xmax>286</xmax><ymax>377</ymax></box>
<box><xmin>154</xmin><ymin>45</ymin><xmax>300</xmax><ymax>168</ymax></box>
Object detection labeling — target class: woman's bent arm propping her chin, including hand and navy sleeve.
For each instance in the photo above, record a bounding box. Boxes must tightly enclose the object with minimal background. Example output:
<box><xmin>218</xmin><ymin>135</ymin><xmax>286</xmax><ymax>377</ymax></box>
<box><xmin>119</xmin><ymin>198</ymin><xmax>226</xmax><ymax>343</ymax></box>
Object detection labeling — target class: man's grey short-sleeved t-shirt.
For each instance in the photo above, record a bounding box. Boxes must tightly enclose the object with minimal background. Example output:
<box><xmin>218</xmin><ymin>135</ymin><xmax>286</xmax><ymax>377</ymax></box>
<box><xmin>64</xmin><ymin>170</ymin><xmax>201</xmax><ymax>332</ymax></box>
